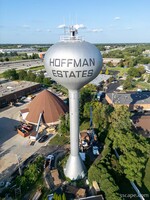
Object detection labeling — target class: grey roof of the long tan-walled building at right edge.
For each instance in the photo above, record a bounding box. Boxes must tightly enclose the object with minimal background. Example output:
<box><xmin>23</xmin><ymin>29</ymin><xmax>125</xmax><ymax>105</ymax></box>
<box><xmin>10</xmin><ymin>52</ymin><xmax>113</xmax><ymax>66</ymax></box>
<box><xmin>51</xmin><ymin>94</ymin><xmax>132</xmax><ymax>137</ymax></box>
<box><xmin>107</xmin><ymin>92</ymin><xmax>150</xmax><ymax>105</ymax></box>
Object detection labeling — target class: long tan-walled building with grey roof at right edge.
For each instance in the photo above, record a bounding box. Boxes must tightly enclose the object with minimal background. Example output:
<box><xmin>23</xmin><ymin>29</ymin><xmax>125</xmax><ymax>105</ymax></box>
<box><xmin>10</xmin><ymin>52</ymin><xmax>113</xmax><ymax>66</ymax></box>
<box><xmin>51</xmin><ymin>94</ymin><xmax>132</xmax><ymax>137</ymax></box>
<box><xmin>105</xmin><ymin>91</ymin><xmax>150</xmax><ymax>111</ymax></box>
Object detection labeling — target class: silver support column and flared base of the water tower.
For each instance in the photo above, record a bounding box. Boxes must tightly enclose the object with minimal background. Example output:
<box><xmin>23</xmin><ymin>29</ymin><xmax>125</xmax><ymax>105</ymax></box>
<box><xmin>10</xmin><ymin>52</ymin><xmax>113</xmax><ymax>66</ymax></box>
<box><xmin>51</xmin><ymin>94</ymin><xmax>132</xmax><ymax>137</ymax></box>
<box><xmin>64</xmin><ymin>90</ymin><xmax>85</xmax><ymax>180</ymax></box>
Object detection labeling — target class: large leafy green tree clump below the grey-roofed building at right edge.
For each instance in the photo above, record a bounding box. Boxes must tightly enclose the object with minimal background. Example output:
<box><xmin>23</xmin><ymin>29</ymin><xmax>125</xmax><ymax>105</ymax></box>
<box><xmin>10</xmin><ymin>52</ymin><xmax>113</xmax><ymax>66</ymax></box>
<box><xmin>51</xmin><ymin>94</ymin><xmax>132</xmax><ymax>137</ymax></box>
<box><xmin>109</xmin><ymin>106</ymin><xmax>150</xmax><ymax>186</ymax></box>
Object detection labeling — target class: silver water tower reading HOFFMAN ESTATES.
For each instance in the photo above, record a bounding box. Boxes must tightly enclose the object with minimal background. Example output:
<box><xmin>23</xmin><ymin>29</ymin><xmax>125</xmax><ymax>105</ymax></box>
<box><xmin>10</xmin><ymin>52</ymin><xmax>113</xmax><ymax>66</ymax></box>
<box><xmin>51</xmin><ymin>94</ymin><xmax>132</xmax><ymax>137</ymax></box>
<box><xmin>44</xmin><ymin>27</ymin><xmax>102</xmax><ymax>180</ymax></box>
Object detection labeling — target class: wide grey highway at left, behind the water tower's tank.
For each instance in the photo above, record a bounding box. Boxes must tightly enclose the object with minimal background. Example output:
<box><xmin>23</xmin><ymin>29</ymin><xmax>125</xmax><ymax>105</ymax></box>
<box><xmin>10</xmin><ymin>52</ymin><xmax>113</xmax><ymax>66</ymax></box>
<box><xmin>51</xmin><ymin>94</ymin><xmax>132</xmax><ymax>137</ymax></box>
<box><xmin>0</xmin><ymin>59</ymin><xmax>43</xmax><ymax>73</ymax></box>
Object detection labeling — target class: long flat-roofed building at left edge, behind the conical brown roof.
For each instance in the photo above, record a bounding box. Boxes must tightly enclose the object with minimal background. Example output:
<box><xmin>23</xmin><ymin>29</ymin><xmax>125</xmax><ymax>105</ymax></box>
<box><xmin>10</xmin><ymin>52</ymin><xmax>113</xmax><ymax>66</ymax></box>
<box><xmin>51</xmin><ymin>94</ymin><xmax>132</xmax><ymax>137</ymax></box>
<box><xmin>0</xmin><ymin>81</ymin><xmax>41</xmax><ymax>108</ymax></box>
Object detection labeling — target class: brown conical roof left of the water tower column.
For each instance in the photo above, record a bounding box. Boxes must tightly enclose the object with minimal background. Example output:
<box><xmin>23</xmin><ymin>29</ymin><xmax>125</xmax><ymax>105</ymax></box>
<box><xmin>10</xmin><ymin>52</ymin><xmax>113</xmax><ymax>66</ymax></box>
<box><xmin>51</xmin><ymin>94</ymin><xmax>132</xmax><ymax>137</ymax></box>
<box><xmin>26</xmin><ymin>90</ymin><xmax>68</xmax><ymax>124</ymax></box>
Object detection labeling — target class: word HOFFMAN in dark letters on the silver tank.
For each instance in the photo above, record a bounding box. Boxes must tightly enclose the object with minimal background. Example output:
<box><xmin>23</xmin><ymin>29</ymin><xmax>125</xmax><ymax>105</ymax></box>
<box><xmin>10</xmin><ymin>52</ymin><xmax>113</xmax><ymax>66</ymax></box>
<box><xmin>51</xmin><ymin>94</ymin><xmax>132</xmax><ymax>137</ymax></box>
<box><xmin>49</xmin><ymin>58</ymin><xmax>95</xmax><ymax>67</ymax></box>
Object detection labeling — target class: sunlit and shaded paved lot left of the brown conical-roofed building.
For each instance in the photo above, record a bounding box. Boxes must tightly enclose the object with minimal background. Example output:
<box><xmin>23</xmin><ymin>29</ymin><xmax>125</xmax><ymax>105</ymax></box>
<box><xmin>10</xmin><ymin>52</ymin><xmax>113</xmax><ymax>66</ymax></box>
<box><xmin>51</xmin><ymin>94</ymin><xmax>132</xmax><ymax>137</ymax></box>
<box><xmin>0</xmin><ymin>104</ymin><xmax>52</xmax><ymax>180</ymax></box>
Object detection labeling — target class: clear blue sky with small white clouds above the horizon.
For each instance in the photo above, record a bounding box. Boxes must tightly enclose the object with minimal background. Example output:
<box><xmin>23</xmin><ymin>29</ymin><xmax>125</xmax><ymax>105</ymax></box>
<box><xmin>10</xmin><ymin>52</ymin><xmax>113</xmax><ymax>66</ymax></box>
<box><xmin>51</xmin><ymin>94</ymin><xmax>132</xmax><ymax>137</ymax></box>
<box><xmin>0</xmin><ymin>0</ymin><xmax>150</xmax><ymax>43</ymax></box>
